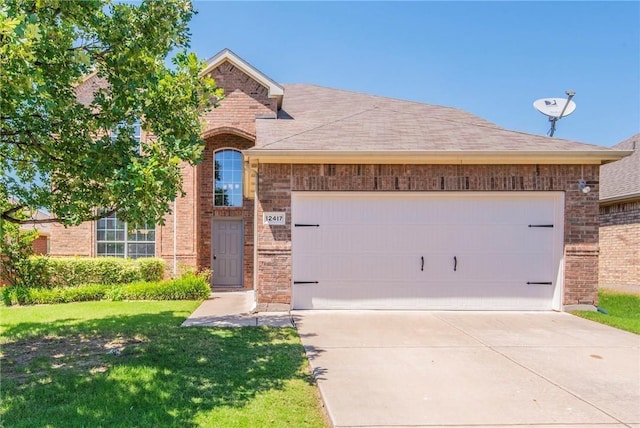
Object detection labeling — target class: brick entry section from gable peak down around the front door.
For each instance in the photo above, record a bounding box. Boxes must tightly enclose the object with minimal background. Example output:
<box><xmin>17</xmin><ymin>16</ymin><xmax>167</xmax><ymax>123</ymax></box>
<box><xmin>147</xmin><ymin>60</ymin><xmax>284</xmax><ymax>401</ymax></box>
<box><xmin>156</xmin><ymin>57</ymin><xmax>277</xmax><ymax>288</ymax></box>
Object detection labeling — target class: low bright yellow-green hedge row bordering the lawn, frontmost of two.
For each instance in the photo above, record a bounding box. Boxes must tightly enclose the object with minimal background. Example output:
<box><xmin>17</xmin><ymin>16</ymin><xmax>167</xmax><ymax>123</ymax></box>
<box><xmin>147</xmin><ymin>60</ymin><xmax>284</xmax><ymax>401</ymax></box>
<box><xmin>2</xmin><ymin>274</ymin><xmax>210</xmax><ymax>306</ymax></box>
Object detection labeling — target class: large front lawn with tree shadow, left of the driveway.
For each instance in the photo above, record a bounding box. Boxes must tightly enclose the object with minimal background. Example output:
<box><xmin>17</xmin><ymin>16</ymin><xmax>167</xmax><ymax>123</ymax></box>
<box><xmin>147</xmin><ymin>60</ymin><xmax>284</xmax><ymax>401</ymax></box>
<box><xmin>0</xmin><ymin>301</ymin><xmax>325</xmax><ymax>427</ymax></box>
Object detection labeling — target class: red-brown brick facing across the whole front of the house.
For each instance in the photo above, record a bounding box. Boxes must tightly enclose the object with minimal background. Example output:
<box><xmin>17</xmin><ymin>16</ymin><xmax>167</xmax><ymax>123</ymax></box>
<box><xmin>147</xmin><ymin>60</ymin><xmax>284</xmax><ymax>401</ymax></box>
<box><xmin>50</xmin><ymin>57</ymin><xmax>604</xmax><ymax>309</ymax></box>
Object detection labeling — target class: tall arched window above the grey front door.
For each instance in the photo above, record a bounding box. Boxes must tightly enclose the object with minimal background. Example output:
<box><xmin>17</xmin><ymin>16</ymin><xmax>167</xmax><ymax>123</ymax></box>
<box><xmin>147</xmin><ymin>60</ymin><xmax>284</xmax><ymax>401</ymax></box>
<box><xmin>213</xmin><ymin>150</ymin><xmax>242</xmax><ymax>207</ymax></box>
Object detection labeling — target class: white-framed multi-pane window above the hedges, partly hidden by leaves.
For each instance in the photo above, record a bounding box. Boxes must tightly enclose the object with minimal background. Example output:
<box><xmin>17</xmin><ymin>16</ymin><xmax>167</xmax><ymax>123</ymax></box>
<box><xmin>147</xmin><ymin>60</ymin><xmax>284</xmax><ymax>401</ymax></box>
<box><xmin>96</xmin><ymin>214</ymin><xmax>156</xmax><ymax>259</ymax></box>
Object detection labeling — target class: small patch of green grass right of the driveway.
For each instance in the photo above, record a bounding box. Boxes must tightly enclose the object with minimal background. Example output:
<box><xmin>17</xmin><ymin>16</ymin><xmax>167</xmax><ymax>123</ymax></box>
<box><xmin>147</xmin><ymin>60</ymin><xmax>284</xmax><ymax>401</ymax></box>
<box><xmin>575</xmin><ymin>290</ymin><xmax>640</xmax><ymax>334</ymax></box>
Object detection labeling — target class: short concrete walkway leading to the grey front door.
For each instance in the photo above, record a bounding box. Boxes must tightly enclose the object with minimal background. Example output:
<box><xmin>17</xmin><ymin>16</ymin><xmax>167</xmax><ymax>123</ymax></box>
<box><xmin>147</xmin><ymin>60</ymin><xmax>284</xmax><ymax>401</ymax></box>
<box><xmin>182</xmin><ymin>290</ymin><xmax>293</xmax><ymax>327</ymax></box>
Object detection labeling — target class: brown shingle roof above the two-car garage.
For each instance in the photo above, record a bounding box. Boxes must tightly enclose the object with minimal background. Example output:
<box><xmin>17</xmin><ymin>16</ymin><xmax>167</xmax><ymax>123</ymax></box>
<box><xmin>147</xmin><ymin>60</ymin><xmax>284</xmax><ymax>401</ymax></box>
<box><xmin>254</xmin><ymin>84</ymin><xmax>624</xmax><ymax>153</ymax></box>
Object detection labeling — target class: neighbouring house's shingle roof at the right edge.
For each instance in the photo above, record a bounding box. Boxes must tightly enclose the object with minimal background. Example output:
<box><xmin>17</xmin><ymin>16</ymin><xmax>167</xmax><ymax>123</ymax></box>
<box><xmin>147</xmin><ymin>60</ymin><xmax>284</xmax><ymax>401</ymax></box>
<box><xmin>600</xmin><ymin>134</ymin><xmax>640</xmax><ymax>201</ymax></box>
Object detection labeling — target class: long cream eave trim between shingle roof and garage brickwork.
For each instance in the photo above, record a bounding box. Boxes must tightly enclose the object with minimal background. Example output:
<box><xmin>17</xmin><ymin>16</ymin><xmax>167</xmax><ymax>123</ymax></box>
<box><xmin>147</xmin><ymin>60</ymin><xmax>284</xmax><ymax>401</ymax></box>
<box><xmin>244</xmin><ymin>148</ymin><xmax>632</xmax><ymax>165</ymax></box>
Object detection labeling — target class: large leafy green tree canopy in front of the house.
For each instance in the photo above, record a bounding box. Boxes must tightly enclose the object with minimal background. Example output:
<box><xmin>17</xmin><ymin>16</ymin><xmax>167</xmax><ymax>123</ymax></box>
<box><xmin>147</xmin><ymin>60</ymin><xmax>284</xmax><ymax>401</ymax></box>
<box><xmin>0</xmin><ymin>0</ymin><xmax>222</xmax><ymax>229</ymax></box>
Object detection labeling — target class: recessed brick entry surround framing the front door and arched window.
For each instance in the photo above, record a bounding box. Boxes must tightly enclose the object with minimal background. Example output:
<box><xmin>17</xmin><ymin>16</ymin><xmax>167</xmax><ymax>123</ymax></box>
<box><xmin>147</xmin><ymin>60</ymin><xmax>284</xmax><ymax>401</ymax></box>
<box><xmin>198</xmin><ymin>134</ymin><xmax>254</xmax><ymax>288</ymax></box>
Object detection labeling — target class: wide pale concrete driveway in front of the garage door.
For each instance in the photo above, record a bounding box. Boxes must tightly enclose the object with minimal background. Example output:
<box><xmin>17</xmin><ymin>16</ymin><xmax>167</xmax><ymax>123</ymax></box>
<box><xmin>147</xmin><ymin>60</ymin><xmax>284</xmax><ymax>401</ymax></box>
<box><xmin>293</xmin><ymin>311</ymin><xmax>640</xmax><ymax>428</ymax></box>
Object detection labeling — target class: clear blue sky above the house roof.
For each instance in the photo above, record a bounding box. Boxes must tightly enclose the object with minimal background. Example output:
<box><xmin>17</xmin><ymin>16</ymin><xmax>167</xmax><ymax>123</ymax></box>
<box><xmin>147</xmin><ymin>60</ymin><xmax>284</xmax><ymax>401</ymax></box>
<box><xmin>186</xmin><ymin>0</ymin><xmax>640</xmax><ymax>146</ymax></box>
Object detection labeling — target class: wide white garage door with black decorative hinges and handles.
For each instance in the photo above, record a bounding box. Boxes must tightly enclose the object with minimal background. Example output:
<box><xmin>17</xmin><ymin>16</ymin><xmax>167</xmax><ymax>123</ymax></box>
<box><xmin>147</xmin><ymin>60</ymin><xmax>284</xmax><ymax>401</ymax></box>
<box><xmin>292</xmin><ymin>192</ymin><xmax>564</xmax><ymax>310</ymax></box>
